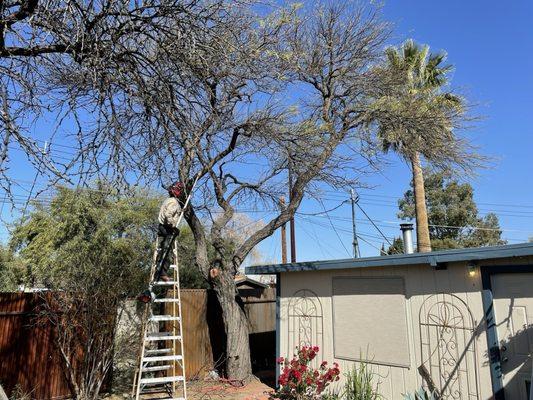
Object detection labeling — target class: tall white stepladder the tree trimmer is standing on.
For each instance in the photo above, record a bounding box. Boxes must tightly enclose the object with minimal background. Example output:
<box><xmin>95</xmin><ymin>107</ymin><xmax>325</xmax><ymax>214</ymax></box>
<box><xmin>133</xmin><ymin>240</ymin><xmax>187</xmax><ymax>400</ymax></box>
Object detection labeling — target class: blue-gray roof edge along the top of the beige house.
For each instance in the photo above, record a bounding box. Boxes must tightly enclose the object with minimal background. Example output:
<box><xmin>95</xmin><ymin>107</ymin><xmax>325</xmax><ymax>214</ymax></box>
<box><xmin>246</xmin><ymin>243</ymin><xmax>533</xmax><ymax>274</ymax></box>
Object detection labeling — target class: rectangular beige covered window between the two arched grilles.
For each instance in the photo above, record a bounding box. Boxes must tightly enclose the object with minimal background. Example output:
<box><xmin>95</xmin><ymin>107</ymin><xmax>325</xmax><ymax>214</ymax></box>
<box><xmin>333</xmin><ymin>277</ymin><xmax>409</xmax><ymax>367</ymax></box>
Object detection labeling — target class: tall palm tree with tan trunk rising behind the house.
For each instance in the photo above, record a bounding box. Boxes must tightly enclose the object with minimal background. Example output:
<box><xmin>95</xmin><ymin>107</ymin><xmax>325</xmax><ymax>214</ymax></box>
<box><xmin>368</xmin><ymin>40</ymin><xmax>470</xmax><ymax>252</ymax></box>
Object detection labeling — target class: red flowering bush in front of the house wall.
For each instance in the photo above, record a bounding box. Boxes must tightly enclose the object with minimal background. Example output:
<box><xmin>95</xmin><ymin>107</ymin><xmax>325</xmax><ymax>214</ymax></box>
<box><xmin>270</xmin><ymin>346</ymin><xmax>340</xmax><ymax>400</ymax></box>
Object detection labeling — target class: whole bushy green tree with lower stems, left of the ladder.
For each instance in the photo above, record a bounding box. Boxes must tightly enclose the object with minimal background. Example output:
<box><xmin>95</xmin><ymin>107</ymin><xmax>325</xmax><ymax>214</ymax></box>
<box><xmin>4</xmin><ymin>184</ymin><xmax>160</xmax><ymax>399</ymax></box>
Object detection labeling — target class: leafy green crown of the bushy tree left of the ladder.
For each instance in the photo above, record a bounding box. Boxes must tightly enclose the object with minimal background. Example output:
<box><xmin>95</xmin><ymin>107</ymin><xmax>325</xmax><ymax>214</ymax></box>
<box><xmin>10</xmin><ymin>185</ymin><xmax>159</xmax><ymax>290</ymax></box>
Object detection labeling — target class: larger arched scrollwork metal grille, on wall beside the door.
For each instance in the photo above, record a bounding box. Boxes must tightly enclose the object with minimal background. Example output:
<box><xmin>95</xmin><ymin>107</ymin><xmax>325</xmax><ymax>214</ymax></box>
<box><xmin>420</xmin><ymin>294</ymin><xmax>479</xmax><ymax>400</ymax></box>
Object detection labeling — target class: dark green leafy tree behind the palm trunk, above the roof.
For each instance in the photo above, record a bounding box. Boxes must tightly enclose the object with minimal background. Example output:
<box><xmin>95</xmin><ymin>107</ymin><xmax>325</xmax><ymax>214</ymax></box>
<box><xmin>398</xmin><ymin>169</ymin><xmax>506</xmax><ymax>250</ymax></box>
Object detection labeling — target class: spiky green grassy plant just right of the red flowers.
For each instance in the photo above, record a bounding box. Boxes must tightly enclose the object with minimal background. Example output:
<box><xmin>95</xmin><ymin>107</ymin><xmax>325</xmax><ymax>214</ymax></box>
<box><xmin>342</xmin><ymin>361</ymin><xmax>381</xmax><ymax>400</ymax></box>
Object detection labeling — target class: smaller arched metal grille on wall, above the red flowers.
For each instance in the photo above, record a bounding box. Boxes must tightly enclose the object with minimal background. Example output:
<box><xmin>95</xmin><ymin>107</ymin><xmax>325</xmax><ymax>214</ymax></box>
<box><xmin>287</xmin><ymin>289</ymin><xmax>324</xmax><ymax>364</ymax></box>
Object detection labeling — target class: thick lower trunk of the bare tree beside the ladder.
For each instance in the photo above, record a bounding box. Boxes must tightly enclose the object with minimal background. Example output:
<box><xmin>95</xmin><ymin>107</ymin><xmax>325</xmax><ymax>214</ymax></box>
<box><xmin>214</xmin><ymin>271</ymin><xmax>252</xmax><ymax>380</ymax></box>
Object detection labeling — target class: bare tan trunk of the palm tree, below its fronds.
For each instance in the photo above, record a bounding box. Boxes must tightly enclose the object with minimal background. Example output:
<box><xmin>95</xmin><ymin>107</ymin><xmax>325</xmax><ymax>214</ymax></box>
<box><xmin>411</xmin><ymin>153</ymin><xmax>431</xmax><ymax>253</ymax></box>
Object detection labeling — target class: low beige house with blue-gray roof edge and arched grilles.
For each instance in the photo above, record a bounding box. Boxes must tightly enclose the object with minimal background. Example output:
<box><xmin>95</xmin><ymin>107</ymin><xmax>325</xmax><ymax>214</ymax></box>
<box><xmin>246</xmin><ymin>243</ymin><xmax>533</xmax><ymax>400</ymax></box>
